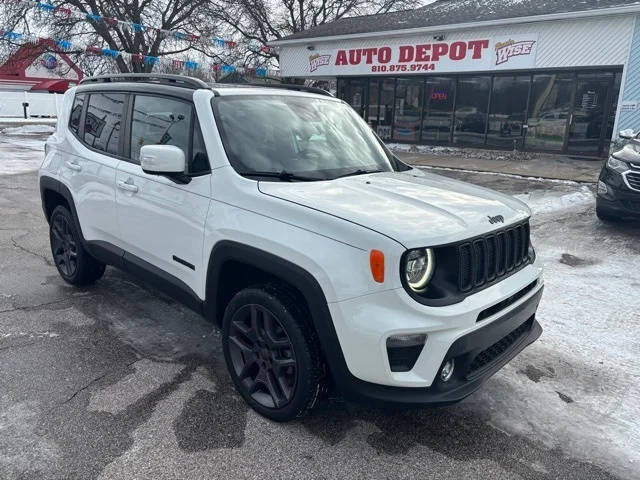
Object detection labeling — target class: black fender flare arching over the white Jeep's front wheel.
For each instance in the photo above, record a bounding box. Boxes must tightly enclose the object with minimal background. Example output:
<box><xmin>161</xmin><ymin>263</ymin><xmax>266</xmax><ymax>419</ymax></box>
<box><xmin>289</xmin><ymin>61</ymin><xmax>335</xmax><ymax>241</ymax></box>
<box><xmin>204</xmin><ymin>244</ymin><xmax>355</xmax><ymax>390</ymax></box>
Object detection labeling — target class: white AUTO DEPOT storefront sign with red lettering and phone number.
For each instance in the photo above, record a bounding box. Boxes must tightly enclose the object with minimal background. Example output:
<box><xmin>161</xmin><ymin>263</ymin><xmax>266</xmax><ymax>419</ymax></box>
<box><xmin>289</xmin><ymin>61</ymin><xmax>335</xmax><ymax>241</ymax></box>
<box><xmin>300</xmin><ymin>34</ymin><xmax>538</xmax><ymax>76</ymax></box>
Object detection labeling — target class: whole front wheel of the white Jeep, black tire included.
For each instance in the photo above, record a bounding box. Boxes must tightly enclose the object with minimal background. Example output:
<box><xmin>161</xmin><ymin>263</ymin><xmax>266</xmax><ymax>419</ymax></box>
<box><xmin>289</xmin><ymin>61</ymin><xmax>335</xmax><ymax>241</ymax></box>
<box><xmin>222</xmin><ymin>285</ymin><xmax>322</xmax><ymax>422</ymax></box>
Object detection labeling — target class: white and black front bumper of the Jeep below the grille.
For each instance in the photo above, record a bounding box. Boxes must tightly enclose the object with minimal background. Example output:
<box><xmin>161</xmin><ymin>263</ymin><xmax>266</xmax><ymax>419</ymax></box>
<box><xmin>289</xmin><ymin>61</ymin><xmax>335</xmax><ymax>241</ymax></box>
<box><xmin>329</xmin><ymin>259</ymin><xmax>543</xmax><ymax>405</ymax></box>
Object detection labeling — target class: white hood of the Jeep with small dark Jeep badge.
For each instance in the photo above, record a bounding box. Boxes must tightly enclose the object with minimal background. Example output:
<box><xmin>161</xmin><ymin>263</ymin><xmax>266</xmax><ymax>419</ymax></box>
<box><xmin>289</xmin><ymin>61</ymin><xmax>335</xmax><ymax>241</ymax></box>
<box><xmin>259</xmin><ymin>169</ymin><xmax>530</xmax><ymax>248</ymax></box>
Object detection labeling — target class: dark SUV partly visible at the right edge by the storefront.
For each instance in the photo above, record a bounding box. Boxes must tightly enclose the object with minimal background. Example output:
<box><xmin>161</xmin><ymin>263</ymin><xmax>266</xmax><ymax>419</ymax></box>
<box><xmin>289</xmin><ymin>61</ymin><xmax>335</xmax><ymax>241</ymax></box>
<box><xmin>596</xmin><ymin>132</ymin><xmax>640</xmax><ymax>220</ymax></box>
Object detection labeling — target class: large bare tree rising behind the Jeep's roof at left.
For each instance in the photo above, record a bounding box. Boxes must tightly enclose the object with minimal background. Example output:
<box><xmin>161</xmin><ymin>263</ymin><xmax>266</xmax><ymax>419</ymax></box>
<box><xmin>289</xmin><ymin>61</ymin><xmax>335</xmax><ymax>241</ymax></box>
<box><xmin>0</xmin><ymin>0</ymin><xmax>238</xmax><ymax>73</ymax></box>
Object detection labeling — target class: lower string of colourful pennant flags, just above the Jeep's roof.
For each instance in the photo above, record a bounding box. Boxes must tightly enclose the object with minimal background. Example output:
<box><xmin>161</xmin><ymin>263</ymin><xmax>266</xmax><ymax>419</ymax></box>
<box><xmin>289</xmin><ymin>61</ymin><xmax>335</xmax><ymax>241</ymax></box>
<box><xmin>0</xmin><ymin>28</ymin><xmax>280</xmax><ymax>77</ymax></box>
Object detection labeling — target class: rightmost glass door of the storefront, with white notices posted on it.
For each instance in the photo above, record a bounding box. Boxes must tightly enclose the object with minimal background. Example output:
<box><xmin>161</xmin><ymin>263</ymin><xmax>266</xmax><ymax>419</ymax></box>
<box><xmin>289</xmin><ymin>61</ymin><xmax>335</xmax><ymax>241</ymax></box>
<box><xmin>567</xmin><ymin>72</ymin><xmax>614</xmax><ymax>156</ymax></box>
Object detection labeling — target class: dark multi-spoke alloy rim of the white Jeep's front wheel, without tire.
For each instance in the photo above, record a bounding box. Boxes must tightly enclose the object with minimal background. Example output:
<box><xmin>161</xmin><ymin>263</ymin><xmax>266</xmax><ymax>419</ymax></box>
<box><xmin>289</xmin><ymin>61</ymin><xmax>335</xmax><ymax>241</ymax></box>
<box><xmin>229</xmin><ymin>304</ymin><xmax>298</xmax><ymax>408</ymax></box>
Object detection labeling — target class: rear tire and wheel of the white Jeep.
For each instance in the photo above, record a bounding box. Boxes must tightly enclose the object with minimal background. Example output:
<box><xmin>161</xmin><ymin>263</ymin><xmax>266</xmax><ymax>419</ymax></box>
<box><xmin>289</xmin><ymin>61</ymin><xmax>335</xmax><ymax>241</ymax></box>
<box><xmin>49</xmin><ymin>205</ymin><xmax>106</xmax><ymax>286</ymax></box>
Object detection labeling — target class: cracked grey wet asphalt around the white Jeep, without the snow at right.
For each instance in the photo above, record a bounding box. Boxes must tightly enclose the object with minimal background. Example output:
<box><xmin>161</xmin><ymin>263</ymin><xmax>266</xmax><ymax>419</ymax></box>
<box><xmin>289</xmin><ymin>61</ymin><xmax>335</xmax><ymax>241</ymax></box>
<box><xmin>0</xmin><ymin>157</ymin><xmax>640</xmax><ymax>480</ymax></box>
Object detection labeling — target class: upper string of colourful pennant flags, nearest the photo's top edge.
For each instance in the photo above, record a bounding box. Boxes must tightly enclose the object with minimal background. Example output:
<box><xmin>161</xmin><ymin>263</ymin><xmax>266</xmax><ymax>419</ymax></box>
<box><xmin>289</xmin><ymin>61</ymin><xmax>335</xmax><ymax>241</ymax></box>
<box><xmin>0</xmin><ymin>0</ymin><xmax>274</xmax><ymax>54</ymax></box>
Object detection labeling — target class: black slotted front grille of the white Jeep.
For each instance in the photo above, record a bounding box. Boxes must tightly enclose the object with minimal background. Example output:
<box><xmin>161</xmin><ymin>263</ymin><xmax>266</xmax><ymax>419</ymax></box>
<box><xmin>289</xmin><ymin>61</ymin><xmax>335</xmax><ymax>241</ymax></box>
<box><xmin>458</xmin><ymin>222</ymin><xmax>529</xmax><ymax>293</ymax></box>
